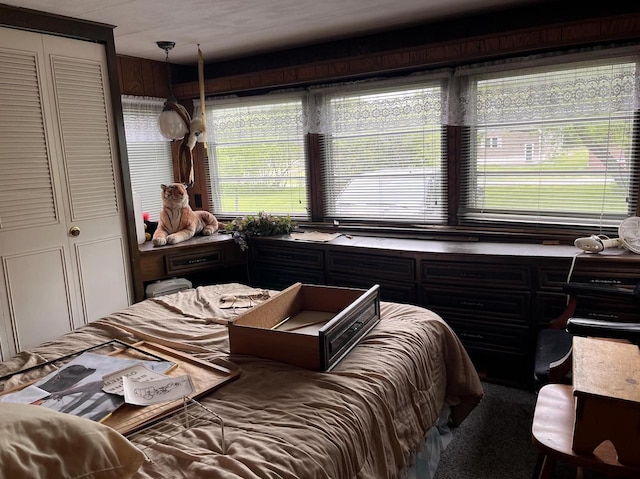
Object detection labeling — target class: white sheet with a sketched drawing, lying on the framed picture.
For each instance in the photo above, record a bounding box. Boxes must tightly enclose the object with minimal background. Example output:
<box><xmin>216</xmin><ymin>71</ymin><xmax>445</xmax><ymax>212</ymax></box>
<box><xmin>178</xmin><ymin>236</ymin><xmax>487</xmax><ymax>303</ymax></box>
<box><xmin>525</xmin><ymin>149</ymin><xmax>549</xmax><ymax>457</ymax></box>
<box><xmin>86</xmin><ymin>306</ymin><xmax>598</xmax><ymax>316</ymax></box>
<box><xmin>122</xmin><ymin>374</ymin><xmax>194</xmax><ymax>406</ymax></box>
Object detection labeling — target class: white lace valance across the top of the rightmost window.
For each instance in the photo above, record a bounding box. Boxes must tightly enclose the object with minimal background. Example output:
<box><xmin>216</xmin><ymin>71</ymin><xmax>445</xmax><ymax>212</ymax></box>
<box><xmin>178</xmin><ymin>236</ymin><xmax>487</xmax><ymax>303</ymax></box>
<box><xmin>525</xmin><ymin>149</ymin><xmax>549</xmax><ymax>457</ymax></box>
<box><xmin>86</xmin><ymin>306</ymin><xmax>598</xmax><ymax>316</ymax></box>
<box><xmin>447</xmin><ymin>46</ymin><xmax>640</xmax><ymax>126</ymax></box>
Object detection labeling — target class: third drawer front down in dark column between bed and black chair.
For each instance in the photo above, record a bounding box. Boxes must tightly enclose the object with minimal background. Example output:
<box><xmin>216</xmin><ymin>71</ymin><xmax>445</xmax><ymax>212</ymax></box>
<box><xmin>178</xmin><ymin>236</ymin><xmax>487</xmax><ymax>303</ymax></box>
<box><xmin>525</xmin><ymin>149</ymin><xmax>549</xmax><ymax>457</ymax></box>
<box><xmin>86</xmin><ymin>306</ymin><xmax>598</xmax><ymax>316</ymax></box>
<box><xmin>447</xmin><ymin>319</ymin><xmax>530</xmax><ymax>356</ymax></box>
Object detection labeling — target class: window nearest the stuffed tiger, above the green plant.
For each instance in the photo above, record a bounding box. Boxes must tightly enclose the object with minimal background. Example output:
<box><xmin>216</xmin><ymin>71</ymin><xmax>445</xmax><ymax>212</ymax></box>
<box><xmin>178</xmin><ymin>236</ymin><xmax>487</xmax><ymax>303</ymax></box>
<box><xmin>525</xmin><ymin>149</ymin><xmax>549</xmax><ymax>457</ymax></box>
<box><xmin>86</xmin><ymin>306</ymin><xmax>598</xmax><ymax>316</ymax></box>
<box><xmin>206</xmin><ymin>95</ymin><xmax>309</xmax><ymax>219</ymax></box>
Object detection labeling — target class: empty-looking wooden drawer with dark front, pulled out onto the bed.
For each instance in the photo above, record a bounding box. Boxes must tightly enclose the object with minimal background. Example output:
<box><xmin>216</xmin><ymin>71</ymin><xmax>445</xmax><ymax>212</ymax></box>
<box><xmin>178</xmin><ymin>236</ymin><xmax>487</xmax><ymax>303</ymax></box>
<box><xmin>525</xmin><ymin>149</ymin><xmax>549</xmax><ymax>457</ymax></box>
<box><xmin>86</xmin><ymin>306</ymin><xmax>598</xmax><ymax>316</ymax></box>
<box><xmin>229</xmin><ymin>283</ymin><xmax>380</xmax><ymax>371</ymax></box>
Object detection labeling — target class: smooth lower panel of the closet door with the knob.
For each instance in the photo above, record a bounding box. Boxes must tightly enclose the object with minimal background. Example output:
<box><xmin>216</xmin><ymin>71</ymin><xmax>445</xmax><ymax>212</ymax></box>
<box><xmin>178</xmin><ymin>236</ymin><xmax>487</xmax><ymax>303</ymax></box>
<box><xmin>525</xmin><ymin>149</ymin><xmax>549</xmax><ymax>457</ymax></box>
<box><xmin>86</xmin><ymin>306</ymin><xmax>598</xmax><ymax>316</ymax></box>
<box><xmin>76</xmin><ymin>237</ymin><xmax>129</xmax><ymax>322</ymax></box>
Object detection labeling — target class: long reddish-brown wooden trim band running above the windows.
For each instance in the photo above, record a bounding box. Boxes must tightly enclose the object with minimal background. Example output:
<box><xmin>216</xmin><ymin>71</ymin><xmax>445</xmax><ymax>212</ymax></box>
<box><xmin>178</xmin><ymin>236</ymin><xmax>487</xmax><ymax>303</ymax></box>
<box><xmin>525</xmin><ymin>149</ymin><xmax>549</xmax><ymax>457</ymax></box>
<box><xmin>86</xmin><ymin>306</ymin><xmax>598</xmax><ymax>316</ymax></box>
<box><xmin>174</xmin><ymin>7</ymin><xmax>640</xmax><ymax>99</ymax></box>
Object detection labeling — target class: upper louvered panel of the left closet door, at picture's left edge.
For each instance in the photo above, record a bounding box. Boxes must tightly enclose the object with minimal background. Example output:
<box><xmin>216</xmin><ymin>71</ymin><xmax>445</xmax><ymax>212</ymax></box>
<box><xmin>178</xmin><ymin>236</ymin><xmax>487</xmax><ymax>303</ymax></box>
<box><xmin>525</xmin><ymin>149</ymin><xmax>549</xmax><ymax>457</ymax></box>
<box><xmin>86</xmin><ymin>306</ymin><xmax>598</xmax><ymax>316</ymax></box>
<box><xmin>0</xmin><ymin>37</ymin><xmax>58</xmax><ymax>231</ymax></box>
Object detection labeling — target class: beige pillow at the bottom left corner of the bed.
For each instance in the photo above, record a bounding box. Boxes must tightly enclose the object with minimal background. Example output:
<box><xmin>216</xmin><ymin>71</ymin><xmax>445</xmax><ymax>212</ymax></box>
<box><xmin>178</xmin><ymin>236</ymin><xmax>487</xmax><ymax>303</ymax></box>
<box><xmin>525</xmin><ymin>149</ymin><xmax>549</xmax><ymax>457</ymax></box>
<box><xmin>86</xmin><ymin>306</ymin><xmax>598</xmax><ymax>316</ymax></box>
<box><xmin>0</xmin><ymin>403</ymin><xmax>145</xmax><ymax>479</ymax></box>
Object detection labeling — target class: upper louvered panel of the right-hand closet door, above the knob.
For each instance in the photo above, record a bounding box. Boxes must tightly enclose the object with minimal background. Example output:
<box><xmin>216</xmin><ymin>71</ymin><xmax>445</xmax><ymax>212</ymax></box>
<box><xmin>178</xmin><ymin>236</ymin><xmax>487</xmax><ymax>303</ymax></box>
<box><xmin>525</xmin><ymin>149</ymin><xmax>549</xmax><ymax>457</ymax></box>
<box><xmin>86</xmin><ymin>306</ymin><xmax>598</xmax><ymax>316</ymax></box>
<box><xmin>50</xmin><ymin>55</ymin><xmax>118</xmax><ymax>221</ymax></box>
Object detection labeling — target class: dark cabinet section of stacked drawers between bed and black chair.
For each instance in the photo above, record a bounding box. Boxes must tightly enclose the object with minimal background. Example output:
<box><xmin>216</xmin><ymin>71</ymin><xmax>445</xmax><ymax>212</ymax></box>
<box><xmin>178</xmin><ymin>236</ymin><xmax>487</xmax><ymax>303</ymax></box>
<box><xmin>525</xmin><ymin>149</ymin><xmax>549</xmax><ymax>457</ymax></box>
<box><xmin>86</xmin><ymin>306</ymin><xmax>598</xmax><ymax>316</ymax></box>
<box><xmin>420</xmin><ymin>257</ymin><xmax>533</xmax><ymax>388</ymax></box>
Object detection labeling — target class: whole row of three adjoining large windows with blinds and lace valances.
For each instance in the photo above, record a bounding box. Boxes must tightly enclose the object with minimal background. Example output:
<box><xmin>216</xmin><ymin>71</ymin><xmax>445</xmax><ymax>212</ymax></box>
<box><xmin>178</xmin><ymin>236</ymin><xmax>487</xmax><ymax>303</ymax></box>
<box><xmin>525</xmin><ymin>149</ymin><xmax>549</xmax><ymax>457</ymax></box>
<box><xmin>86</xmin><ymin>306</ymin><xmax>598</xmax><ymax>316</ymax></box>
<box><xmin>196</xmin><ymin>47</ymin><xmax>640</xmax><ymax>233</ymax></box>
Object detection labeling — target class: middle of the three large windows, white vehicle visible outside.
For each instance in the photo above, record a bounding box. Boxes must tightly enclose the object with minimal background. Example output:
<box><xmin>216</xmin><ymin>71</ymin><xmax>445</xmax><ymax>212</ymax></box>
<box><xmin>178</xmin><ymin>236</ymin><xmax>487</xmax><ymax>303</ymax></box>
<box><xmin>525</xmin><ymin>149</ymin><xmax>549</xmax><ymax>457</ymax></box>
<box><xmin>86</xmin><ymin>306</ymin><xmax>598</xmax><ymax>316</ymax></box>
<box><xmin>318</xmin><ymin>79</ymin><xmax>447</xmax><ymax>223</ymax></box>
